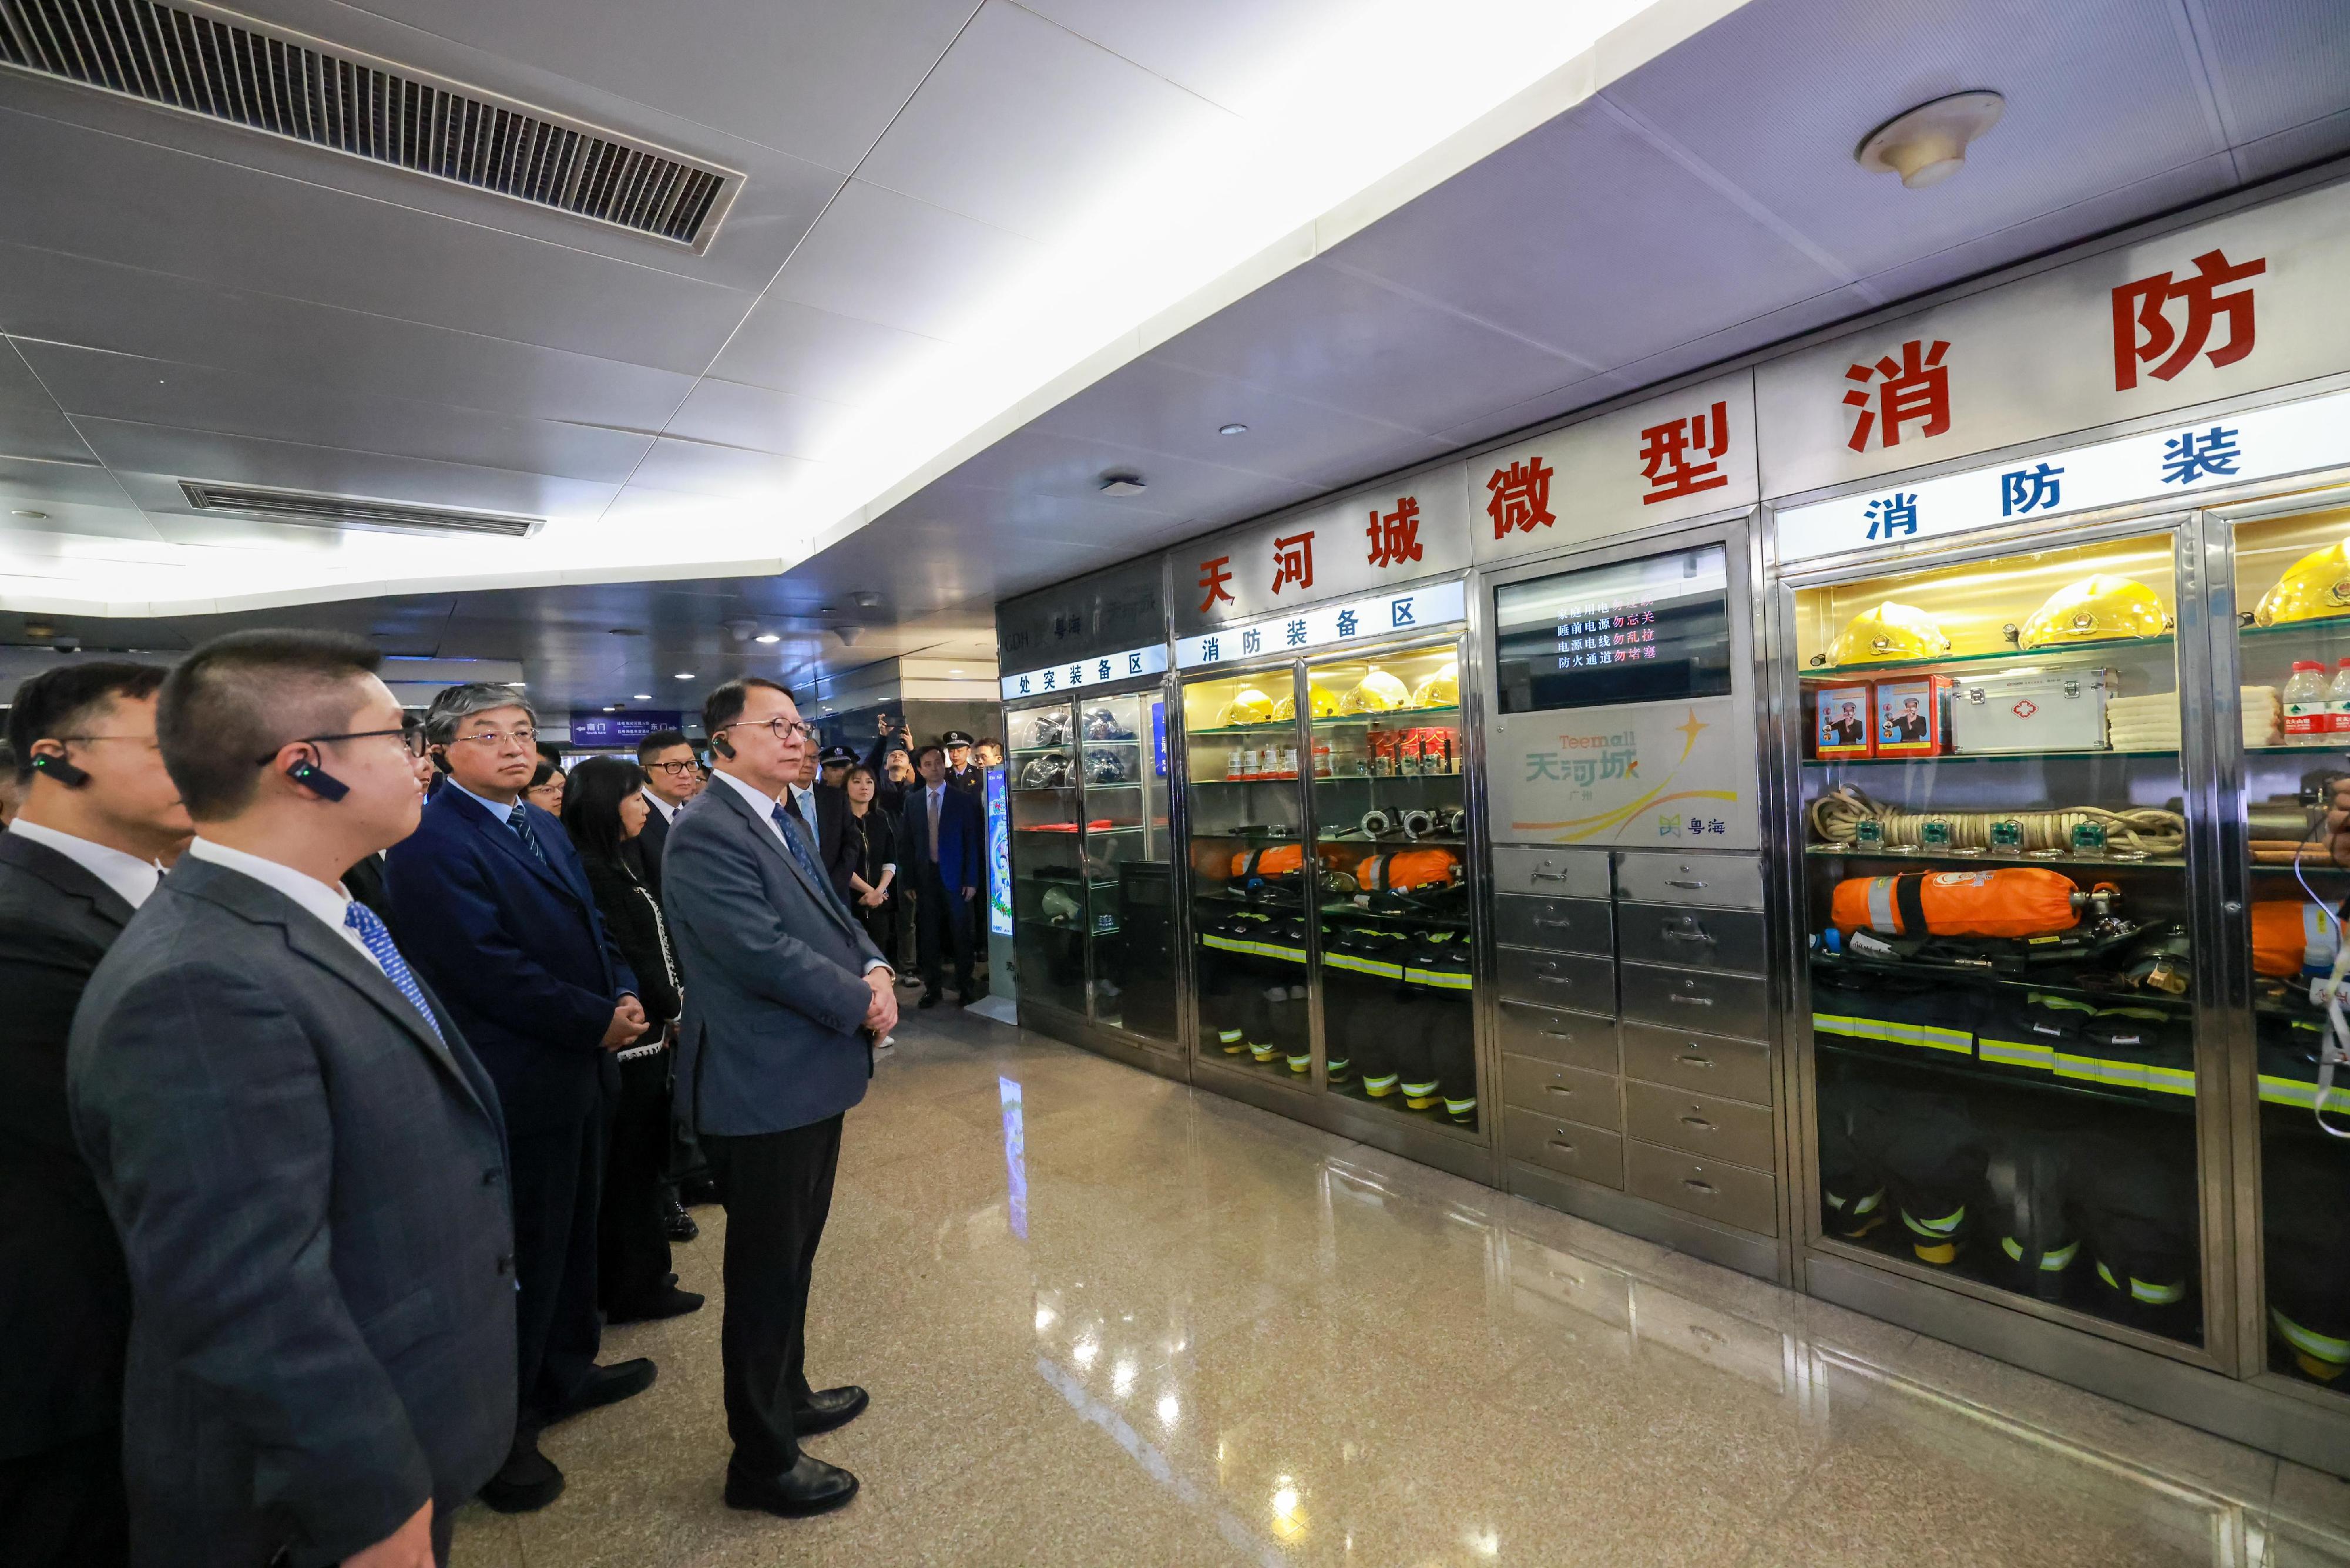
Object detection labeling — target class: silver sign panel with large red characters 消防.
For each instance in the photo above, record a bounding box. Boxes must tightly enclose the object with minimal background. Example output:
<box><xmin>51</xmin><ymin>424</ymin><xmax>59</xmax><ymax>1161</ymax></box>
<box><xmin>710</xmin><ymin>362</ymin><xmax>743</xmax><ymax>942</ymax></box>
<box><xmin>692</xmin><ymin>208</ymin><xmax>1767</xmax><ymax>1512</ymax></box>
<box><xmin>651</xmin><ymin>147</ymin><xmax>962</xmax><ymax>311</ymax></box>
<box><xmin>1755</xmin><ymin>175</ymin><xmax>2350</xmax><ymax>496</ymax></box>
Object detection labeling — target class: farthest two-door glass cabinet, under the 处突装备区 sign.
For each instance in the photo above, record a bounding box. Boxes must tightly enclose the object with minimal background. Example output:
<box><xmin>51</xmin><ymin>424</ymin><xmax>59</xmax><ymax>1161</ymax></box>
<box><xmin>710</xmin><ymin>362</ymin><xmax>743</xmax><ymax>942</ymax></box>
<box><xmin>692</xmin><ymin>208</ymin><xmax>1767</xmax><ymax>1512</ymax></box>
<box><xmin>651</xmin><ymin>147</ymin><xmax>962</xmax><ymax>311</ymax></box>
<box><xmin>1003</xmin><ymin>679</ymin><xmax>1184</xmax><ymax>1077</ymax></box>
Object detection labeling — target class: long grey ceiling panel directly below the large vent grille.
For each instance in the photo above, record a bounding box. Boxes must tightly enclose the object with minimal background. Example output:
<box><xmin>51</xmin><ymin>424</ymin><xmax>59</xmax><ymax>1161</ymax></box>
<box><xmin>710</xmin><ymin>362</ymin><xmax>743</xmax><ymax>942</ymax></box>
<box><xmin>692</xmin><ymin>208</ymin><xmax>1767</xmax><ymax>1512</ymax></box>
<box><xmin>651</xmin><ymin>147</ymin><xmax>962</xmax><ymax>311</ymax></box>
<box><xmin>0</xmin><ymin>103</ymin><xmax>750</xmax><ymax>371</ymax></box>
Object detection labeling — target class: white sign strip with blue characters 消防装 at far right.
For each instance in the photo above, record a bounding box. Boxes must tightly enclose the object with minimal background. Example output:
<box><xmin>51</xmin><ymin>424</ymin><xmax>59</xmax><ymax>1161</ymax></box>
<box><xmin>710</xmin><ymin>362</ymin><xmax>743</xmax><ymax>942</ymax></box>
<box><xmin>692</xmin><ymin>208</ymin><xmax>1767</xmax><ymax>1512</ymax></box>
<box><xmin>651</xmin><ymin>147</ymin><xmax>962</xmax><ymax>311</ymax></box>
<box><xmin>1779</xmin><ymin>381</ymin><xmax>2350</xmax><ymax>562</ymax></box>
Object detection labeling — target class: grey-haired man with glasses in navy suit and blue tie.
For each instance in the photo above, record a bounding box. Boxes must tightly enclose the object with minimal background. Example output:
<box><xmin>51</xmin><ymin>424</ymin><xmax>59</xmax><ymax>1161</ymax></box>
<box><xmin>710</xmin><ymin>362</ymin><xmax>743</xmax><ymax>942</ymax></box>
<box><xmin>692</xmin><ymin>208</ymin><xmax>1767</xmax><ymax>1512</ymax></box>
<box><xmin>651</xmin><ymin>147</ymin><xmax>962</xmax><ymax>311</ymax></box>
<box><xmin>385</xmin><ymin>681</ymin><xmax>653</xmax><ymax>1512</ymax></box>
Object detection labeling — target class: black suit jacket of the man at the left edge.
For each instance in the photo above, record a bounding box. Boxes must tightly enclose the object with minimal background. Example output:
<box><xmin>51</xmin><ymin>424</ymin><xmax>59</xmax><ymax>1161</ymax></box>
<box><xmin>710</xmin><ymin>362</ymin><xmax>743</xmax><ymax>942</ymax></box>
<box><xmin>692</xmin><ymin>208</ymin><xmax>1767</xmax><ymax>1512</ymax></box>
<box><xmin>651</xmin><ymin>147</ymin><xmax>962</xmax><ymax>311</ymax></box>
<box><xmin>0</xmin><ymin>832</ymin><xmax>132</xmax><ymax>1458</ymax></box>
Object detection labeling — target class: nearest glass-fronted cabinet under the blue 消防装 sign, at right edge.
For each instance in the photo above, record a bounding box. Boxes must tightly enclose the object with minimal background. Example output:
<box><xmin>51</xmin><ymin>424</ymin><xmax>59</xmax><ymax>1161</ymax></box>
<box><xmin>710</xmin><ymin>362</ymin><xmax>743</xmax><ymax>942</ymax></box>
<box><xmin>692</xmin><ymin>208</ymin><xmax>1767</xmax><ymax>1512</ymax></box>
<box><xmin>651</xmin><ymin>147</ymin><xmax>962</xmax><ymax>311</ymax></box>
<box><xmin>1765</xmin><ymin>475</ymin><xmax>2350</xmax><ymax>1472</ymax></box>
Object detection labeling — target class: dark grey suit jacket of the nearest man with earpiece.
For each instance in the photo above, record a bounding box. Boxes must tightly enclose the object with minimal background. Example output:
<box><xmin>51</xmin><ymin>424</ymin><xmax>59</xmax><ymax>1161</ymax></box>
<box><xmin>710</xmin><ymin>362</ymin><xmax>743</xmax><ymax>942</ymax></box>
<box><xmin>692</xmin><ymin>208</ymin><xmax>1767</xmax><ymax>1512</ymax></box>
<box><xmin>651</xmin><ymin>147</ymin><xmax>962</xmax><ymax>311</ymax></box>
<box><xmin>68</xmin><ymin>858</ymin><xmax>515</xmax><ymax>1568</ymax></box>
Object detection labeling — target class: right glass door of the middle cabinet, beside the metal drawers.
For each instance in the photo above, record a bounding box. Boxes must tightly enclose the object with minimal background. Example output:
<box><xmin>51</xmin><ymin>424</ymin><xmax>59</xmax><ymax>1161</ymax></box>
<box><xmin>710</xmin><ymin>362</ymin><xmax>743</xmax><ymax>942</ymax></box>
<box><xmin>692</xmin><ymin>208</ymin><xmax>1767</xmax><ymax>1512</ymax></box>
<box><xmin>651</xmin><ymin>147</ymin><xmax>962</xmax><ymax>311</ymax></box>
<box><xmin>1307</xmin><ymin>639</ymin><xmax>1478</xmax><ymax>1129</ymax></box>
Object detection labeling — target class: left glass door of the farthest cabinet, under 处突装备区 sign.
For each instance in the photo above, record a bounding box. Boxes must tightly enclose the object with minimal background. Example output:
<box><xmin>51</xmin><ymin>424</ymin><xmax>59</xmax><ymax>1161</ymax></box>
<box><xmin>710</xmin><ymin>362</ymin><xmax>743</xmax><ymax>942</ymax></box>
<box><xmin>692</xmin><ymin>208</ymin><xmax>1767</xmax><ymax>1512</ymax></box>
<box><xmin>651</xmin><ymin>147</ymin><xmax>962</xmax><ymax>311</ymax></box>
<box><xmin>1003</xmin><ymin>703</ymin><xmax>1100</xmax><ymax>1013</ymax></box>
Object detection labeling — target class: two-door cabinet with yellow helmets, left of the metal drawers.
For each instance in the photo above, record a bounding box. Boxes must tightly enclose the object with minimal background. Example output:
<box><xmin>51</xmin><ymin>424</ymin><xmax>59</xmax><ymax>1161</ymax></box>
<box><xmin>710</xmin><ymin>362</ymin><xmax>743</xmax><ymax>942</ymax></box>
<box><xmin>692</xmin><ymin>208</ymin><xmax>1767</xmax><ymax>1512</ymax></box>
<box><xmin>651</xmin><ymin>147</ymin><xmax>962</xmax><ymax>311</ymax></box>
<box><xmin>1175</xmin><ymin>606</ymin><xmax>1495</xmax><ymax>1183</ymax></box>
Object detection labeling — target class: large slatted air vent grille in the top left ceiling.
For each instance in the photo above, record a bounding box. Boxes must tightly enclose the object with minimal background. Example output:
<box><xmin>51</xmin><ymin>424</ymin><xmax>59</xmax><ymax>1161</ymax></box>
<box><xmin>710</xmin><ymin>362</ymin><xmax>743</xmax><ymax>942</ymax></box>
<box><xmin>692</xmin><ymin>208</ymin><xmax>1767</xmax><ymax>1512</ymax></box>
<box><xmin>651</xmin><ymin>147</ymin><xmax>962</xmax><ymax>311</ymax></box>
<box><xmin>0</xmin><ymin>0</ymin><xmax>733</xmax><ymax>249</ymax></box>
